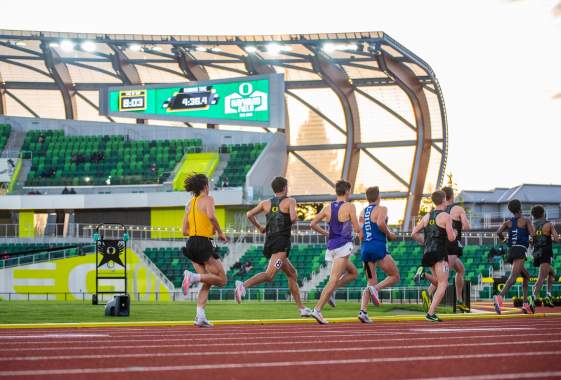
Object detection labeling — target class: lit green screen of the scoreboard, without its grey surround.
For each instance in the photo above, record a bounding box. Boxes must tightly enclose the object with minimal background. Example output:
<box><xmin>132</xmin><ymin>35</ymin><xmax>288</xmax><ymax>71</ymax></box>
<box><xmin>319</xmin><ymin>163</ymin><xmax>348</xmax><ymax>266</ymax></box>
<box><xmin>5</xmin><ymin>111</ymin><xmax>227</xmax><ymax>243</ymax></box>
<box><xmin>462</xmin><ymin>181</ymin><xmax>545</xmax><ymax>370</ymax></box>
<box><xmin>107</xmin><ymin>78</ymin><xmax>270</xmax><ymax>123</ymax></box>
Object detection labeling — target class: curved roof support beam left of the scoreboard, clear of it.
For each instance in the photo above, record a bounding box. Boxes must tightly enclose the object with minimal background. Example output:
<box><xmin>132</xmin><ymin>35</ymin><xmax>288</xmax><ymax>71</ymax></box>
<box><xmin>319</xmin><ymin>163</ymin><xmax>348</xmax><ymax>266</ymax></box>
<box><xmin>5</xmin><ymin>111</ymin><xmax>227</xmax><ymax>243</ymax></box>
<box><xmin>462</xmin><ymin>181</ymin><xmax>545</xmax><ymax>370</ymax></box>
<box><xmin>41</xmin><ymin>41</ymin><xmax>78</xmax><ymax>120</ymax></box>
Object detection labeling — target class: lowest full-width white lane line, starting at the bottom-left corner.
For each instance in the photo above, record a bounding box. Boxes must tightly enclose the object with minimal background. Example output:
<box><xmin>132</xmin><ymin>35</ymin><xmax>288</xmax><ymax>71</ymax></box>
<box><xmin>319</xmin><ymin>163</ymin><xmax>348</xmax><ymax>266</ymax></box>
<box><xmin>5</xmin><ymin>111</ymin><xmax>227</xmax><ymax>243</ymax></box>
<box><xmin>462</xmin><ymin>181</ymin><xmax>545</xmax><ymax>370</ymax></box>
<box><xmin>0</xmin><ymin>351</ymin><xmax>561</xmax><ymax>377</ymax></box>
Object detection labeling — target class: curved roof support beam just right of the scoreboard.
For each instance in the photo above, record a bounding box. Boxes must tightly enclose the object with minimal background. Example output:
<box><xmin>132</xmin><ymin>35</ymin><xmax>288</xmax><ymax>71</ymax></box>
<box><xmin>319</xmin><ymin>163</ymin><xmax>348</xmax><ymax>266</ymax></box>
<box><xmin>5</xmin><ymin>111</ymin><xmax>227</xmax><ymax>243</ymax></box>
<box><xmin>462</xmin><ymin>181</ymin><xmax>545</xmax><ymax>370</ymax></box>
<box><xmin>309</xmin><ymin>47</ymin><xmax>360</xmax><ymax>187</ymax></box>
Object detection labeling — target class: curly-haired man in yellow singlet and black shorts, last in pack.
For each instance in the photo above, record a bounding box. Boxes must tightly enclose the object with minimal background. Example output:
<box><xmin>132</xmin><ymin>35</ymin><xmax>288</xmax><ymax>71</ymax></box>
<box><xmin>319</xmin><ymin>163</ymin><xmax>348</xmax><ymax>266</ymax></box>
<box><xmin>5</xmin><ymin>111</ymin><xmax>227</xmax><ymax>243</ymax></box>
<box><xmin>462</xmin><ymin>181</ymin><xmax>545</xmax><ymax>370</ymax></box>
<box><xmin>182</xmin><ymin>174</ymin><xmax>228</xmax><ymax>327</ymax></box>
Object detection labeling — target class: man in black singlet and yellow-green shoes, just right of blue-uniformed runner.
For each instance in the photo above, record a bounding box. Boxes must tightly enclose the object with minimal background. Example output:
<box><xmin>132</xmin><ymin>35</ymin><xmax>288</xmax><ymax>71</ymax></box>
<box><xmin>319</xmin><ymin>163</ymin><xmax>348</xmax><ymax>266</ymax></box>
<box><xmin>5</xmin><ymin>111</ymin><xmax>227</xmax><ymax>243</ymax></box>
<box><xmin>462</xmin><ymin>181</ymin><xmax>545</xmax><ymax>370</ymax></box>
<box><xmin>411</xmin><ymin>191</ymin><xmax>456</xmax><ymax>322</ymax></box>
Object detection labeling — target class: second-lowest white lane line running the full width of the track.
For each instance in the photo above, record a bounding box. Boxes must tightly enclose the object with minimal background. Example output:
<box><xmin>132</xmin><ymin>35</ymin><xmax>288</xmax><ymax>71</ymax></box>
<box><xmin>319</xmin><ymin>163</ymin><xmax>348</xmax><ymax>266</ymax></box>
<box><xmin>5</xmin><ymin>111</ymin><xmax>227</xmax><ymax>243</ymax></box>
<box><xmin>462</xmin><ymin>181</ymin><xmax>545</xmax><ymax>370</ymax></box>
<box><xmin>0</xmin><ymin>339</ymin><xmax>561</xmax><ymax>362</ymax></box>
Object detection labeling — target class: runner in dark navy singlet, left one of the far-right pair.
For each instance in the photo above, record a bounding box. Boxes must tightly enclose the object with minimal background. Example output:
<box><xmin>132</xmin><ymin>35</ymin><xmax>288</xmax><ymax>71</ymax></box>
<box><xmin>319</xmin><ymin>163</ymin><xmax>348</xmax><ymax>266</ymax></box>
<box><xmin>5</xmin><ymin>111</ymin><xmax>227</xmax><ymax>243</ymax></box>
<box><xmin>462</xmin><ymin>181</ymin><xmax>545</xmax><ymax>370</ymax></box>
<box><xmin>493</xmin><ymin>199</ymin><xmax>535</xmax><ymax>314</ymax></box>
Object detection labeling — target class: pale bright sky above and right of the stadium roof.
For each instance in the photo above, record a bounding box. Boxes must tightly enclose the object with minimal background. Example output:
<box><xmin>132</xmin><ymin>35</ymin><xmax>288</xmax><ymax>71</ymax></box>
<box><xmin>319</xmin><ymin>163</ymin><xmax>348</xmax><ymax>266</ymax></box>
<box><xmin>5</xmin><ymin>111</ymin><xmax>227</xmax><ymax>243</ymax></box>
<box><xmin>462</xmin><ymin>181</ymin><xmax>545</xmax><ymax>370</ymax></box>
<box><xmin>0</xmin><ymin>0</ymin><xmax>561</xmax><ymax>190</ymax></box>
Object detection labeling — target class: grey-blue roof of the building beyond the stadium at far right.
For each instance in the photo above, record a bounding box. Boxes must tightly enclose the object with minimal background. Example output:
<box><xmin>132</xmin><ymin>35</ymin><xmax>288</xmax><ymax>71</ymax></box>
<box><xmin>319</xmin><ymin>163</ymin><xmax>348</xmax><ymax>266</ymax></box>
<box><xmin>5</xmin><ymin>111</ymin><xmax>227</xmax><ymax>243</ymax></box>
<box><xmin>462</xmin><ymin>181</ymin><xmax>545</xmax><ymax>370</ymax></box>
<box><xmin>460</xmin><ymin>184</ymin><xmax>561</xmax><ymax>204</ymax></box>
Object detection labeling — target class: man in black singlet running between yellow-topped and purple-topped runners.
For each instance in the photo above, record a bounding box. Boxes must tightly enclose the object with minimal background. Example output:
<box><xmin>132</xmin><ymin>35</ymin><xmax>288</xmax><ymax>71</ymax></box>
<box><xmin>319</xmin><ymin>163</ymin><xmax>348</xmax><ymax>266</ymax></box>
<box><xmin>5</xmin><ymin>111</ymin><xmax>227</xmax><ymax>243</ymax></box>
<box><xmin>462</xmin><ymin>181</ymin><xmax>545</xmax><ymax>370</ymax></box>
<box><xmin>235</xmin><ymin>177</ymin><xmax>312</xmax><ymax>317</ymax></box>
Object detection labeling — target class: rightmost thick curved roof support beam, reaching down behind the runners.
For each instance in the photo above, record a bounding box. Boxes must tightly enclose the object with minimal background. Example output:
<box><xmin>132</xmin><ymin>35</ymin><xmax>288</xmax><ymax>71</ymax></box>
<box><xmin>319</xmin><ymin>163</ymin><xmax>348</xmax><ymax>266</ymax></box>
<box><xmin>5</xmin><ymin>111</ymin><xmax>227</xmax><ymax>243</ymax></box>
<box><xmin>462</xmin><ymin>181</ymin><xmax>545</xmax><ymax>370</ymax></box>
<box><xmin>378</xmin><ymin>52</ymin><xmax>433</xmax><ymax>231</ymax></box>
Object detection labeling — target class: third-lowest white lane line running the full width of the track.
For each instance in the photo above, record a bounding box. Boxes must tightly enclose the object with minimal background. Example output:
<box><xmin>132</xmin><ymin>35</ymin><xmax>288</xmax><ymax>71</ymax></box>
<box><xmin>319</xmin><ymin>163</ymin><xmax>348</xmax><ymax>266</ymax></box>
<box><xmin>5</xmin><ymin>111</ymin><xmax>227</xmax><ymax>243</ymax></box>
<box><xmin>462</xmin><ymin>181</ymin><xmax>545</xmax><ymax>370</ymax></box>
<box><xmin>0</xmin><ymin>333</ymin><xmax>561</xmax><ymax>352</ymax></box>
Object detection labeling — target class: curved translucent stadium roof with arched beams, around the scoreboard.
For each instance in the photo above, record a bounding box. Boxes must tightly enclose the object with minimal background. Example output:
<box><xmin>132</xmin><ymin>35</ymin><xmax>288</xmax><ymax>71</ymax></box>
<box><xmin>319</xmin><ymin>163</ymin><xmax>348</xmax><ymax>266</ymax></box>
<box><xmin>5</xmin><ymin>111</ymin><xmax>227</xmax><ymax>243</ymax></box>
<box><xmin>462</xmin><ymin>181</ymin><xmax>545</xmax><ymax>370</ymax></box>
<box><xmin>0</xmin><ymin>30</ymin><xmax>447</xmax><ymax>229</ymax></box>
